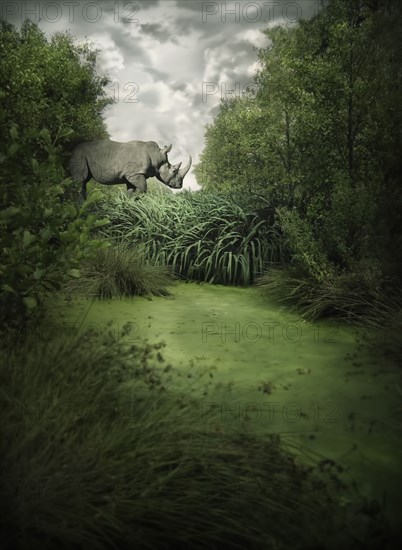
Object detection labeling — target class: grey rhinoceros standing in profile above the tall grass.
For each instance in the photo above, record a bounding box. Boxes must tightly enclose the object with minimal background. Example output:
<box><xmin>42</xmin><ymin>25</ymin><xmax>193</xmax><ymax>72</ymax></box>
<box><xmin>69</xmin><ymin>139</ymin><xmax>192</xmax><ymax>200</ymax></box>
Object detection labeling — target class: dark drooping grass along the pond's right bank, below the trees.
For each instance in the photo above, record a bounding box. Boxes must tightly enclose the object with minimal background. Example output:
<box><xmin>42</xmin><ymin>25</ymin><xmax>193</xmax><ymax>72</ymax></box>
<box><xmin>256</xmin><ymin>268</ymin><xmax>402</xmax><ymax>360</ymax></box>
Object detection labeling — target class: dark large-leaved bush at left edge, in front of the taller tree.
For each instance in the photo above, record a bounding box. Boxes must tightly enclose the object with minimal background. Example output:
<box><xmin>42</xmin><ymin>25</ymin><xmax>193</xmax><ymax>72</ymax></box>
<box><xmin>0</xmin><ymin>125</ymin><xmax>108</xmax><ymax>325</ymax></box>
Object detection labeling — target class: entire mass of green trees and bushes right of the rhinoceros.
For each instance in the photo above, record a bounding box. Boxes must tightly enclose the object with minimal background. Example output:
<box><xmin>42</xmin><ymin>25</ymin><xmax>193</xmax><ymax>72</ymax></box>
<box><xmin>196</xmin><ymin>0</ymin><xmax>402</xmax><ymax>338</ymax></box>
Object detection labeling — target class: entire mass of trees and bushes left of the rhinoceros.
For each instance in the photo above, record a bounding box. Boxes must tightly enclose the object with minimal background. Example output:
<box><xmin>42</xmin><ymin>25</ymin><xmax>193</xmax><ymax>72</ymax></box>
<box><xmin>0</xmin><ymin>20</ymin><xmax>115</xmax><ymax>332</ymax></box>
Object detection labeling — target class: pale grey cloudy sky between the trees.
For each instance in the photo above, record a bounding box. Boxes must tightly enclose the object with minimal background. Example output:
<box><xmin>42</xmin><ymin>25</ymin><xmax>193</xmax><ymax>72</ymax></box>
<box><xmin>0</xmin><ymin>0</ymin><xmax>321</xmax><ymax>189</ymax></box>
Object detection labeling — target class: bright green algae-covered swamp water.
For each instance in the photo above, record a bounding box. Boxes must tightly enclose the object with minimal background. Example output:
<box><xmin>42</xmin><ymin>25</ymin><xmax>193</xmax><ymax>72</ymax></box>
<box><xmin>55</xmin><ymin>283</ymin><xmax>402</xmax><ymax>521</ymax></box>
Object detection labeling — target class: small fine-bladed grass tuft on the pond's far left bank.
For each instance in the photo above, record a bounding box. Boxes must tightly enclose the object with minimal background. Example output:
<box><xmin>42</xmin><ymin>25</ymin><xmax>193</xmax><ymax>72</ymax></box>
<box><xmin>68</xmin><ymin>241</ymin><xmax>172</xmax><ymax>298</ymax></box>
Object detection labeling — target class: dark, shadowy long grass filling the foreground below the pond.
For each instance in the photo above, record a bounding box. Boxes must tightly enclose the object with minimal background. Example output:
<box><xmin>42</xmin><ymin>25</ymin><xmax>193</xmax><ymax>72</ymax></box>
<box><xmin>0</xmin><ymin>327</ymin><xmax>396</xmax><ymax>550</ymax></box>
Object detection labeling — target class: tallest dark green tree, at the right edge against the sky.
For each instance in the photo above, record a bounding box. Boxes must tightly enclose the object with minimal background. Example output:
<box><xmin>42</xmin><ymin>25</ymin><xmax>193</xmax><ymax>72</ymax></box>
<box><xmin>258</xmin><ymin>0</ymin><xmax>402</xmax><ymax>269</ymax></box>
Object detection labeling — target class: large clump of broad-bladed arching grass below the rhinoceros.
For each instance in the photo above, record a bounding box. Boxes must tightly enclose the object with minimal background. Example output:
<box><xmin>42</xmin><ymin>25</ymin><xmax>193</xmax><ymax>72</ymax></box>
<box><xmin>99</xmin><ymin>192</ymin><xmax>283</xmax><ymax>285</ymax></box>
